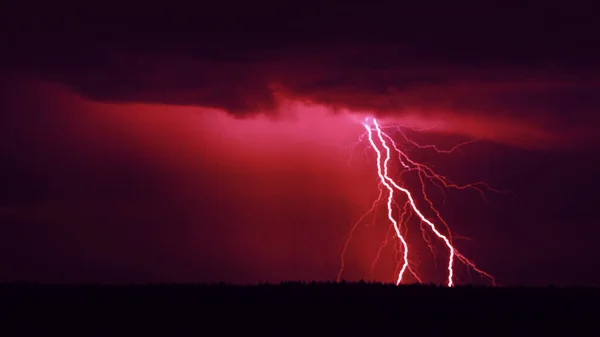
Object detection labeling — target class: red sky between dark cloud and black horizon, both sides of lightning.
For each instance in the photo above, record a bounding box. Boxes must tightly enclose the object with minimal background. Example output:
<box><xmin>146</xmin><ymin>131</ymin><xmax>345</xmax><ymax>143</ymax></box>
<box><xmin>1</xmin><ymin>77</ymin><xmax>593</xmax><ymax>282</ymax></box>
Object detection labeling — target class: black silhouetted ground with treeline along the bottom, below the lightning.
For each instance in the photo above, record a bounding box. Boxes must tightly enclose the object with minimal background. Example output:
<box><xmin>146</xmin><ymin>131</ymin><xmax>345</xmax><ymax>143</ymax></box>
<box><xmin>0</xmin><ymin>282</ymin><xmax>600</xmax><ymax>337</ymax></box>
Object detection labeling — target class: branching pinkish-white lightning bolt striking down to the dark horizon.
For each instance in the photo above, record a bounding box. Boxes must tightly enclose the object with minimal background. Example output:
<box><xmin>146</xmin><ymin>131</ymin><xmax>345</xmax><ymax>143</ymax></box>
<box><xmin>337</xmin><ymin>118</ymin><xmax>507</xmax><ymax>287</ymax></box>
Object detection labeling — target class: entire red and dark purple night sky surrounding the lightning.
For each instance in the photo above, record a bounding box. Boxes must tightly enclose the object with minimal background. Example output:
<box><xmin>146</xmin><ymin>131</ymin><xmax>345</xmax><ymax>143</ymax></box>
<box><xmin>0</xmin><ymin>1</ymin><xmax>600</xmax><ymax>285</ymax></box>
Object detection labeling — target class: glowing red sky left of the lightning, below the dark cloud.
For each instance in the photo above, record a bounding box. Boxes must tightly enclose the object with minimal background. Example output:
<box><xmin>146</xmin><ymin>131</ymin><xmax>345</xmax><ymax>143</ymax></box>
<box><xmin>2</xmin><ymin>80</ymin><xmax>390</xmax><ymax>282</ymax></box>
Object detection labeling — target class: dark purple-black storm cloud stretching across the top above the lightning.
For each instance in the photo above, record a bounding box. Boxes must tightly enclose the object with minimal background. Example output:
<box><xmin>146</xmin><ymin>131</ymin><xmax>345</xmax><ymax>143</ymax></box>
<box><xmin>3</xmin><ymin>2</ymin><xmax>600</xmax><ymax>131</ymax></box>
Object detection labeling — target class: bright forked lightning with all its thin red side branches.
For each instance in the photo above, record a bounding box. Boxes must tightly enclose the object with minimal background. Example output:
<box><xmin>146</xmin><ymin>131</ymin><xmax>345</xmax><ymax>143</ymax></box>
<box><xmin>338</xmin><ymin>118</ymin><xmax>496</xmax><ymax>287</ymax></box>
